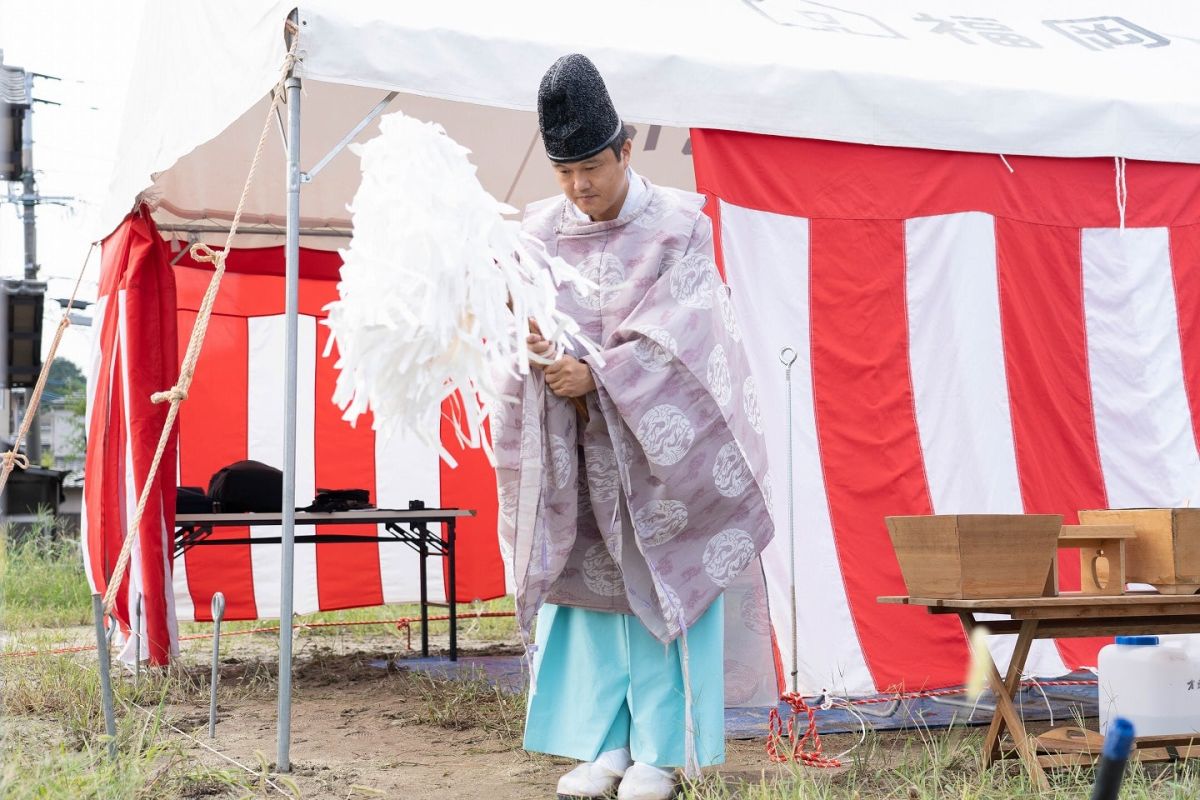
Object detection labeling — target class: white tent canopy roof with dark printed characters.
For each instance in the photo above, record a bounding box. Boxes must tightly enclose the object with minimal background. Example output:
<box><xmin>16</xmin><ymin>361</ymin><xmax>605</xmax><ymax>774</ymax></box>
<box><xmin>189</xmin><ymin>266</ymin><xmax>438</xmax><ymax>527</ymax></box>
<box><xmin>97</xmin><ymin>0</ymin><xmax>1200</xmax><ymax>242</ymax></box>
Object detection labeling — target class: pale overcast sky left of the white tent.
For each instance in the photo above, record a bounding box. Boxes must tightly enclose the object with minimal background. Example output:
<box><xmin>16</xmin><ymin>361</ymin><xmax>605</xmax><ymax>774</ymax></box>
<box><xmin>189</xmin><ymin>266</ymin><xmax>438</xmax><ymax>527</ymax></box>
<box><xmin>0</xmin><ymin>0</ymin><xmax>145</xmax><ymax>376</ymax></box>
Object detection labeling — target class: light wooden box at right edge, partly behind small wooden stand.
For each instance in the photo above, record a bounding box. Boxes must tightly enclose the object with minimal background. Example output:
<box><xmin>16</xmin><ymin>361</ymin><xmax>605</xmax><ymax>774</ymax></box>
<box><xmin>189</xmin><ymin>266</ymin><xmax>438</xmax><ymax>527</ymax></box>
<box><xmin>1079</xmin><ymin>509</ymin><xmax>1200</xmax><ymax>595</ymax></box>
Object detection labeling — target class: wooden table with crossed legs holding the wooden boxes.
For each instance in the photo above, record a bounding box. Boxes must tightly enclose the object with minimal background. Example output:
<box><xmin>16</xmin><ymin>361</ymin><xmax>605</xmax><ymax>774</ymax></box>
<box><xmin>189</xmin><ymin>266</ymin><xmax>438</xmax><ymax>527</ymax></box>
<box><xmin>878</xmin><ymin>593</ymin><xmax>1200</xmax><ymax>789</ymax></box>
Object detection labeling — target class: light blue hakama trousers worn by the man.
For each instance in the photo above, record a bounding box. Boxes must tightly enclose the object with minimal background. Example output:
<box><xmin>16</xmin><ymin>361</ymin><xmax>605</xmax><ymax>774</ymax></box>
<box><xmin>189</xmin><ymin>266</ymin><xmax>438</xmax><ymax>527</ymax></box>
<box><xmin>524</xmin><ymin>596</ymin><xmax>725</xmax><ymax>768</ymax></box>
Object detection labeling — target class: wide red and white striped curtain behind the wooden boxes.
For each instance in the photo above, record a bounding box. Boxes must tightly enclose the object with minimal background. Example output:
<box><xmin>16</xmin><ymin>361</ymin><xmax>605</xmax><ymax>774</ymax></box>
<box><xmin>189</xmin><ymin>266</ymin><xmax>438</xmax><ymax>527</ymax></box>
<box><xmin>692</xmin><ymin>131</ymin><xmax>1200</xmax><ymax>692</ymax></box>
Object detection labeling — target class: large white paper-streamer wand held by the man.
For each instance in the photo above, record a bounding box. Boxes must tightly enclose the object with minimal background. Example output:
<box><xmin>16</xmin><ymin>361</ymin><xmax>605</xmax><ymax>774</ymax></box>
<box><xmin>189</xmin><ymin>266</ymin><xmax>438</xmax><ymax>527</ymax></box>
<box><xmin>325</xmin><ymin>113</ymin><xmax>598</xmax><ymax>465</ymax></box>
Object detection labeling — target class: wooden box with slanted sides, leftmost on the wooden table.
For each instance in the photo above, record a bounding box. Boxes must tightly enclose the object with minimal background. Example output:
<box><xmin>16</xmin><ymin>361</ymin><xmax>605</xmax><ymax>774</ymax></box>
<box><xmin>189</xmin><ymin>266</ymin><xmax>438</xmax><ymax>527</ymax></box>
<box><xmin>887</xmin><ymin>515</ymin><xmax>1062</xmax><ymax>600</ymax></box>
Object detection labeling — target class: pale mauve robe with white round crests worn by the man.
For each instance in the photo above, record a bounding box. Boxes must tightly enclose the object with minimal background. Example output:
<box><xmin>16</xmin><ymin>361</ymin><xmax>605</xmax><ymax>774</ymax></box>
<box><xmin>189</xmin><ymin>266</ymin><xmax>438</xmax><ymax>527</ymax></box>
<box><xmin>493</xmin><ymin>178</ymin><xmax>774</xmax><ymax>642</ymax></box>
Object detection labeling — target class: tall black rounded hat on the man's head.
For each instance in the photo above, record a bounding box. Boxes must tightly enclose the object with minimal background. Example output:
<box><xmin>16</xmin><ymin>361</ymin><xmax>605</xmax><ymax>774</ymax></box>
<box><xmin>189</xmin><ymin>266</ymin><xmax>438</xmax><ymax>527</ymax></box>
<box><xmin>538</xmin><ymin>53</ymin><xmax>622</xmax><ymax>162</ymax></box>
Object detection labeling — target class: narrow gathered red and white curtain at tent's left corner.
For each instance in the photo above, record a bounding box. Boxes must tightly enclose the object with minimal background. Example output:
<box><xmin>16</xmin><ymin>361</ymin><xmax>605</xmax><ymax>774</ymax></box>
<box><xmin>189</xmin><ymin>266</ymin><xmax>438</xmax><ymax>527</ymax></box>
<box><xmin>82</xmin><ymin>212</ymin><xmax>179</xmax><ymax>664</ymax></box>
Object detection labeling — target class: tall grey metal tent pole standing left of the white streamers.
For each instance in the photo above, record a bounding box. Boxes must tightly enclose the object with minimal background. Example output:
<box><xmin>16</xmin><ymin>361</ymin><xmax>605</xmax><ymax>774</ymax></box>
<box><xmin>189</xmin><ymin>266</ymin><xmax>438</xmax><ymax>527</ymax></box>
<box><xmin>275</xmin><ymin>68</ymin><xmax>300</xmax><ymax>772</ymax></box>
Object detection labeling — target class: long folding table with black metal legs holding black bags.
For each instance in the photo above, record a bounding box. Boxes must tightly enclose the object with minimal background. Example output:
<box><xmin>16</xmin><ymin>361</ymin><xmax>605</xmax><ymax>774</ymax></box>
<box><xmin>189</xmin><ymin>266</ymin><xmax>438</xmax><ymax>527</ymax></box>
<box><xmin>175</xmin><ymin>500</ymin><xmax>475</xmax><ymax>661</ymax></box>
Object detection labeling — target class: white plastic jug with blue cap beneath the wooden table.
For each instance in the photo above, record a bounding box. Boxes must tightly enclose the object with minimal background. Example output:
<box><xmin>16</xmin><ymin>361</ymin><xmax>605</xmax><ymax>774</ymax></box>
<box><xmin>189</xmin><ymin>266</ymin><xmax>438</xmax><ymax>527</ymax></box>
<box><xmin>1097</xmin><ymin>636</ymin><xmax>1200</xmax><ymax>739</ymax></box>
